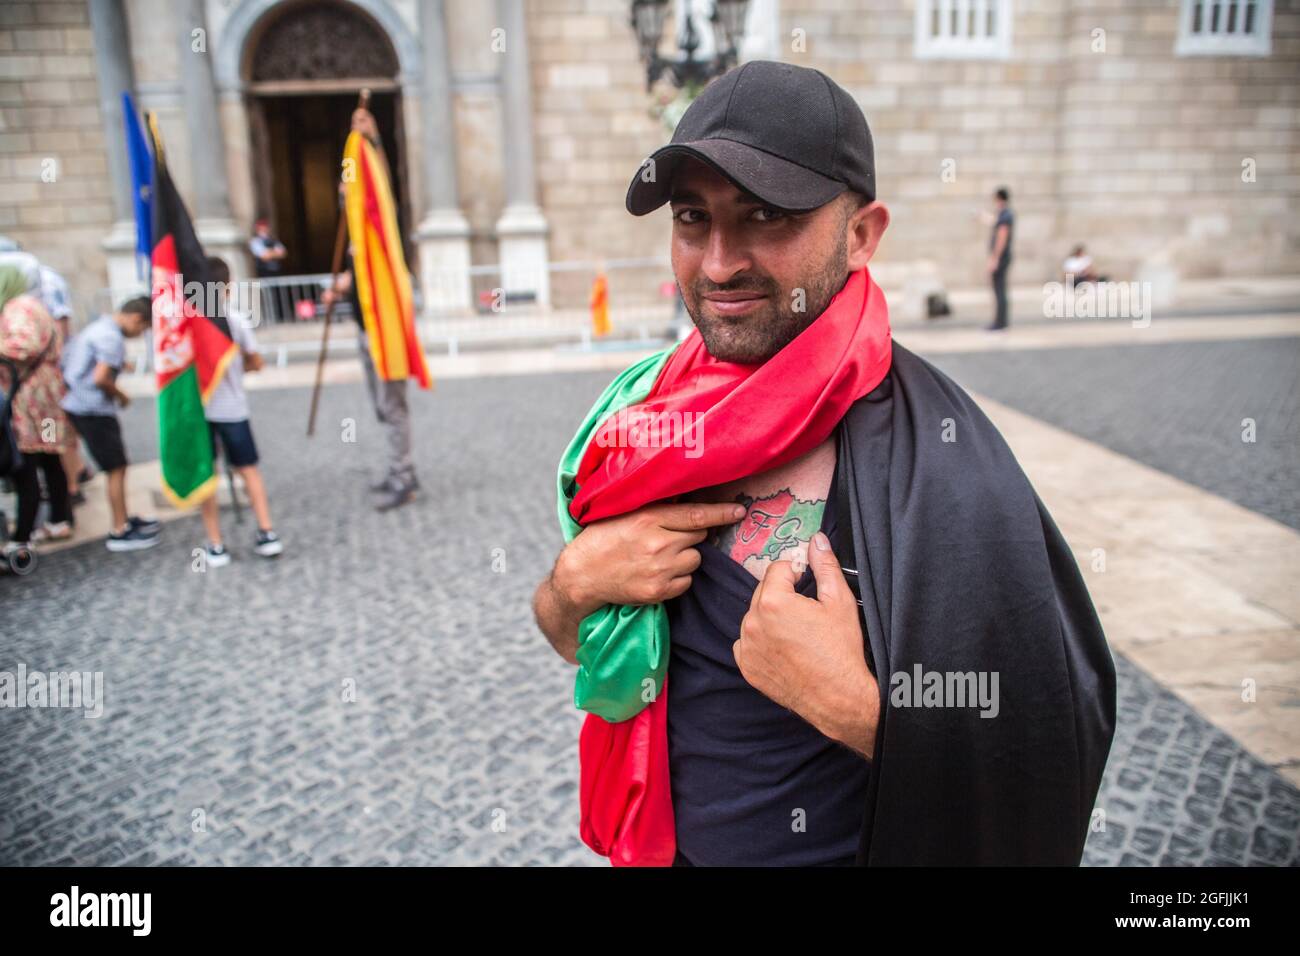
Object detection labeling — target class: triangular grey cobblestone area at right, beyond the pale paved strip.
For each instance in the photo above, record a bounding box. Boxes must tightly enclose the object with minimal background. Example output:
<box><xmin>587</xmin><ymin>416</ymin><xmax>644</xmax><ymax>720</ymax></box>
<box><xmin>920</xmin><ymin>335</ymin><xmax>1300</xmax><ymax>529</ymax></box>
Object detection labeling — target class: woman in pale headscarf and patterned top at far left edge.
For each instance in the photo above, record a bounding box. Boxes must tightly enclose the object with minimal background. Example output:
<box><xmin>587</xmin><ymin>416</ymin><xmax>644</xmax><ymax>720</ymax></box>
<box><xmin>0</xmin><ymin>260</ymin><xmax>72</xmax><ymax>554</ymax></box>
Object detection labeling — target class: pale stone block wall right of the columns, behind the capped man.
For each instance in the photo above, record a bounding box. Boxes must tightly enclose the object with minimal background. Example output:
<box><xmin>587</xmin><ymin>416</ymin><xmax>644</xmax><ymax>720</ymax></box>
<box><xmin>529</xmin><ymin>0</ymin><xmax>1300</xmax><ymax>286</ymax></box>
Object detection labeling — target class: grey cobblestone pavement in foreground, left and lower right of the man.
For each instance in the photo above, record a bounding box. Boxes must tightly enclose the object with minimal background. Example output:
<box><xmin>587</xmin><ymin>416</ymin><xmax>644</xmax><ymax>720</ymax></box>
<box><xmin>0</xmin><ymin>348</ymin><xmax>1300</xmax><ymax>865</ymax></box>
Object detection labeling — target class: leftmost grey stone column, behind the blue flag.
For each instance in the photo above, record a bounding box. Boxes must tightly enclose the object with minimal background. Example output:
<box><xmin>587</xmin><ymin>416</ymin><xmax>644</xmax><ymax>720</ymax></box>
<box><xmin>90</xmin><ymin>0</ymin><xmax>150</xmax><ymax>304</ymax></box>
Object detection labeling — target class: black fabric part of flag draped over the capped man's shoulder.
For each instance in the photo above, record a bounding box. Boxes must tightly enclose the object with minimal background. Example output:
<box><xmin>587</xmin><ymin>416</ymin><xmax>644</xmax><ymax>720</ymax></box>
<box><xmin>839</xmin><ymin>342</ymin><xmax>1115</xmax><ymax>866</ymax></box>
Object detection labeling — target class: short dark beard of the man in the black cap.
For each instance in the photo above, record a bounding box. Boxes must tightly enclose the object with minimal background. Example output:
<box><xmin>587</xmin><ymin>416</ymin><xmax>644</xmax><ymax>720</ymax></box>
<box><xmin>683</xmin><ymin>233</ymin><xmax>849</xmax><ymax>365</ymax></box>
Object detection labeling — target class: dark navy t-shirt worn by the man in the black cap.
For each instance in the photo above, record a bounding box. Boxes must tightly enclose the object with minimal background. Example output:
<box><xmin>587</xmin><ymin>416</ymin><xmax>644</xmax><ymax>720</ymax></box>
<box><xmin>668</xmin><ymin>450</ymin><xmax>871</xmax><ymax>866</ymax></box>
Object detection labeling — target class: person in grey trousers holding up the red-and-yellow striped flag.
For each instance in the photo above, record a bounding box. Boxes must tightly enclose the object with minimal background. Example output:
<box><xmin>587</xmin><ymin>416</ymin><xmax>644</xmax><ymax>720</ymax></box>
<box><xmin>325</xmin><ymin>108</ymin><xmax>420</xmax><ymax>511</ymax></box>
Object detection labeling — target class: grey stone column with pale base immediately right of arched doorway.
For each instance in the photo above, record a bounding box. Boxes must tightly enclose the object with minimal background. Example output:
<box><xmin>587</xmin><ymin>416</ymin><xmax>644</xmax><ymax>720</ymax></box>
<box><xmin>415</xmin><ymin>0</ymin><xmax>472</xmax><ymax>315</ymax></box>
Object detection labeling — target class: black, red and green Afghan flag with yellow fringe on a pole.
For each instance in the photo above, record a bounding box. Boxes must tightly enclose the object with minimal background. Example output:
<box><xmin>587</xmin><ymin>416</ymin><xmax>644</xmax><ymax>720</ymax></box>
<box><xmin>148</xmin><ymin>116</ymin><xmax>238</xmax><ymax>507</ymax></box>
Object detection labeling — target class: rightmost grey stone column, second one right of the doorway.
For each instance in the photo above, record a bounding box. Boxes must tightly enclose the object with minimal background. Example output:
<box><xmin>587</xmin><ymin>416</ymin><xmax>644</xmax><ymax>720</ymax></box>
<box><xmin>497</xmin><ymin>0</ymin><xmax>551</xmax><ymax>306</ymax></box>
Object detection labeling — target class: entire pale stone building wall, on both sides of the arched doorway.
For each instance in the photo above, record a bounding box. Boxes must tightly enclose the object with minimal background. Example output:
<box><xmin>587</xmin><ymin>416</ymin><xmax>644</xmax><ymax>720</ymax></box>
<box><xmin>0</xmin><ymin>0</ymin><xmax>1300</xmax><ymax>321</ymax></box>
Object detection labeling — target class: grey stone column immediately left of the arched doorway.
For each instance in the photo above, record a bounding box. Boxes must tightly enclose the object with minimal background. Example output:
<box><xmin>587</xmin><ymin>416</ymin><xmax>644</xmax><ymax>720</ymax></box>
<box><xmin>177</xmin><ymin>0</ymin><xmax>248</xmax><ymax>281</ymax></box>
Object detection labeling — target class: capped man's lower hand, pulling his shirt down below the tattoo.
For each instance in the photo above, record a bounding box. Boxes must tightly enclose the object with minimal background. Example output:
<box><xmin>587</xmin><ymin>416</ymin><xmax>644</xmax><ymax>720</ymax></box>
<box><xmin>732</xmin><ymin>532</ymin><xmax>880</xmax><ymax>758</ymax></box>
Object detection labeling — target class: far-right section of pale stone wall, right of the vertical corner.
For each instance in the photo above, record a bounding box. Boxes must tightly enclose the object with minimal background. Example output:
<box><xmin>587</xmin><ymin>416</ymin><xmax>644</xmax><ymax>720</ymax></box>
<box><xmin>1060</xmin><ymin>0</ymin><xmax>1300</xmax><ymax>283</ymax></box>
